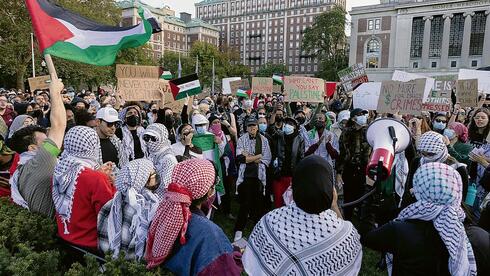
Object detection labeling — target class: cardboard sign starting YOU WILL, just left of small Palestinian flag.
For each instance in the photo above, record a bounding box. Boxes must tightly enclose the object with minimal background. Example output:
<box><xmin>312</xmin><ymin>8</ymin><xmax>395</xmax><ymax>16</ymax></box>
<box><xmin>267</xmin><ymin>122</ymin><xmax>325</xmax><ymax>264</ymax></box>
<box><xmin>116</xmin><ymin>64</ymin><xmax>160</xmax><ymax>102</ymax></box>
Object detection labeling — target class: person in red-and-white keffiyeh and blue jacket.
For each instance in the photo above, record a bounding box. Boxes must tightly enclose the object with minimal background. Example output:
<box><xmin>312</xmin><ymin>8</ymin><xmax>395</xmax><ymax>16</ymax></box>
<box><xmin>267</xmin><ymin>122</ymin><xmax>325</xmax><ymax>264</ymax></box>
<box><xmin>145</xmin><ymin>159</ymin><xmax>240</xmax><ymax>275</ymax></box>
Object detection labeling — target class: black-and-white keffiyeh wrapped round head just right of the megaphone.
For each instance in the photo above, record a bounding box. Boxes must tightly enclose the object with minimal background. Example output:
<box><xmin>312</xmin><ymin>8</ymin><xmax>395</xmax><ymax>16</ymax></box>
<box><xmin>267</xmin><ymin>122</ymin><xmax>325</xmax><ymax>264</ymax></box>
<box><xmin>417</xmin><ymin>131</ymin><xmax>449</xmax><ymax>165</ymax></box>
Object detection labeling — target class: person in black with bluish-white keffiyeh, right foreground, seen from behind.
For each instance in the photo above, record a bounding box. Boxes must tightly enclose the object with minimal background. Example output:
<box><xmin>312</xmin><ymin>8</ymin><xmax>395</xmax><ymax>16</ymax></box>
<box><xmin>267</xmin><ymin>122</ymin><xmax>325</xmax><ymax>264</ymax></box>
<box><xmin>361</xmin><ymin>162</ymin><xmax>477</xmax><ymax>275</ymax></box>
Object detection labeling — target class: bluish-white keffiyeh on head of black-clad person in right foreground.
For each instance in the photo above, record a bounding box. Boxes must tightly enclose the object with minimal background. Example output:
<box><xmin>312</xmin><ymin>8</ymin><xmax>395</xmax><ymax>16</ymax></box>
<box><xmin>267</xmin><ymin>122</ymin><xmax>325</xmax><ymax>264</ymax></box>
<box><xmin>389</xmin><ymin>162</ymin><xmax>476</xmax><ymax>275</ymax></box>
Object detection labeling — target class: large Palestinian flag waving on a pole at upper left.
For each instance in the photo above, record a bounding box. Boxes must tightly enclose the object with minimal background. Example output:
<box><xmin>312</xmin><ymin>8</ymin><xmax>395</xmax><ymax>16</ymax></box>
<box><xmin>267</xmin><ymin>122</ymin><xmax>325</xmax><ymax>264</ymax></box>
<box><xmin>26</xmin><ymin>0</ymin><xmax>161</xmax><ymax>66</ymax></box>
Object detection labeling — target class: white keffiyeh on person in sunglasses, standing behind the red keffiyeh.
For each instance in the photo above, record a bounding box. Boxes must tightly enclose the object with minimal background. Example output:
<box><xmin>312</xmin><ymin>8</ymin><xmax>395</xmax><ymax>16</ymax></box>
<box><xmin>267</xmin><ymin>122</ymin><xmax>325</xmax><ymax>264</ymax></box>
<box><xmin>143</xmin><ymin>123</ymin><xmax>177</xmax><ymax>195</ymax></box>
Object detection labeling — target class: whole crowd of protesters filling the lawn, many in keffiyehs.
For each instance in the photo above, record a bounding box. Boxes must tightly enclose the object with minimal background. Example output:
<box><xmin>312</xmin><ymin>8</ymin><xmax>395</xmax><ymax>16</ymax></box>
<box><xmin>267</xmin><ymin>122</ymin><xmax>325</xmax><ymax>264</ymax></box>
<box><xmin>0</xmin><ymin>80</ymin><xmax>490</xmax><ymax>275</ymax></box>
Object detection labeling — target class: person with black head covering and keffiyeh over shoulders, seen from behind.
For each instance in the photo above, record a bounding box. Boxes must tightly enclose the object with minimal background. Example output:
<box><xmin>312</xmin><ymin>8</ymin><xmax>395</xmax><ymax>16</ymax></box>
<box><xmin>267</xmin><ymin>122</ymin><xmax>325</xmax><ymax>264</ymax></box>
<box><xmin>242</xmin><ymin>155</ymin><xmax>362</xmax><ymax>275</ymax></box>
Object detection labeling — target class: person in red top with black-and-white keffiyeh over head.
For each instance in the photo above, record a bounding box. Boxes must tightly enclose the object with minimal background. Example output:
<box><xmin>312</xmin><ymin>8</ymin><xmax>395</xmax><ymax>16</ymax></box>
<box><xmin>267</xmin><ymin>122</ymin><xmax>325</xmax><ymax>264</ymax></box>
<box><xmin>52</xmin><ymin>126</ymin><xmax>115</xmax><ymax>250</ymax></box>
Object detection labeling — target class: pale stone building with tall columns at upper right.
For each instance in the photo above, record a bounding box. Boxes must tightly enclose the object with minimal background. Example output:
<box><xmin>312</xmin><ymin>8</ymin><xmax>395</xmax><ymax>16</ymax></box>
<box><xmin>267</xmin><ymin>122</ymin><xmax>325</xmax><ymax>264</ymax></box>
<box><xmin>349</xmin><ymin>0</ymin><xmax>490</xmax><ymax>81</ymax></box>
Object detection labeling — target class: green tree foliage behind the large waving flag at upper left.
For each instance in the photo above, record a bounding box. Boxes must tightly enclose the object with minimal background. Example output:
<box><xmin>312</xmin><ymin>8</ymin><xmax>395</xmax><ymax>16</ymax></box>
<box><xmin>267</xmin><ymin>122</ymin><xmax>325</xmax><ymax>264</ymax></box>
<box><xmin>0</xmin><ymin>0</ymin><xmax>156</xmax><ymax>89</ymax></box>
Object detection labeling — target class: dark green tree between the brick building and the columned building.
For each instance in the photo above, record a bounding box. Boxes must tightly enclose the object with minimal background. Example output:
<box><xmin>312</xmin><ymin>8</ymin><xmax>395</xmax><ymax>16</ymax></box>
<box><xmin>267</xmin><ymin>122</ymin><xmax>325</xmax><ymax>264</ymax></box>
<box><xmin>302</xmin><ymin>6</ymin><xmax>348</xmax><ymax>81</ymax></box>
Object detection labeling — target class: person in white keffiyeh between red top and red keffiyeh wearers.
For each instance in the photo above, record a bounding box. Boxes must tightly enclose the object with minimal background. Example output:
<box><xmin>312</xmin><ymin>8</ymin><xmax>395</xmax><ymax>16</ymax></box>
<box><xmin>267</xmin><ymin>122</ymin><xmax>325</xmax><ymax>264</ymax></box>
<box><xmin>97</xmin><ymin>159</ymin><xmax>159</xmax><ymax>260</ymax></box>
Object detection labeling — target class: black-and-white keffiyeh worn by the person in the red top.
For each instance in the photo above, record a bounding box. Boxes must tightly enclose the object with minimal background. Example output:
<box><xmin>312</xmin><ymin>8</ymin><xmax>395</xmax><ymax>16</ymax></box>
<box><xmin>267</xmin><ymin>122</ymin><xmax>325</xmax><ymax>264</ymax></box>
<box><xmin>52</xmin><ymin>126</ymin><xmax>100</xmax><ymax>234</ymax></box>
